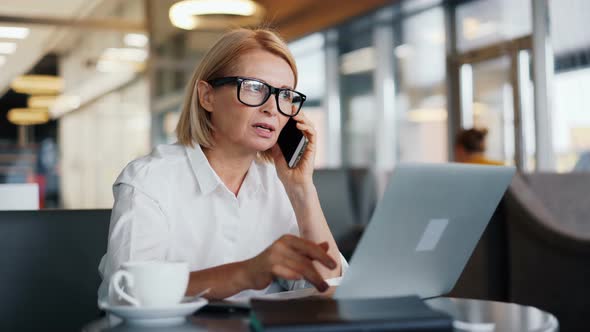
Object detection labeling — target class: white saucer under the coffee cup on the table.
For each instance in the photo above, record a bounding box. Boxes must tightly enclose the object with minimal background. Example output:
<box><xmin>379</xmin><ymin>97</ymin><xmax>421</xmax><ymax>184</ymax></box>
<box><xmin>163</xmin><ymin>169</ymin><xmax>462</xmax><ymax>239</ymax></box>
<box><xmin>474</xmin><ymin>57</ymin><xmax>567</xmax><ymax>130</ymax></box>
<box><xmin>98</xmin><ymin>298</ymin><xmax>208</xmax><ymax>326</ymax></box>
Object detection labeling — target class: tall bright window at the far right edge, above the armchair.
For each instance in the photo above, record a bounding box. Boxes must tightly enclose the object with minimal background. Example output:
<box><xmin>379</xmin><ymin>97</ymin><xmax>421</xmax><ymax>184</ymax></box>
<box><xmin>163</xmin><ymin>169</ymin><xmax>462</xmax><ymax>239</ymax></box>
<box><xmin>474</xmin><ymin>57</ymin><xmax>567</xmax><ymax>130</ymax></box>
<box><xmin>549</xmin><ymin>0</ymin><xmax>590</xmax><ymax>172</ymax></box>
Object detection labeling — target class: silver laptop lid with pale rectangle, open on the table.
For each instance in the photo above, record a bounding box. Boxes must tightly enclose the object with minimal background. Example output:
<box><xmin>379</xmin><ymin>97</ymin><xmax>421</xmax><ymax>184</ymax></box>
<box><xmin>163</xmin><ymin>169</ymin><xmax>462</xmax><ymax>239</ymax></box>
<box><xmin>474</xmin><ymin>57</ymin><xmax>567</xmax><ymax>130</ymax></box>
<box><xmin>334</xmin><ymin>163</ymin><xmax>515</xmax><ymax>298</ymax></box>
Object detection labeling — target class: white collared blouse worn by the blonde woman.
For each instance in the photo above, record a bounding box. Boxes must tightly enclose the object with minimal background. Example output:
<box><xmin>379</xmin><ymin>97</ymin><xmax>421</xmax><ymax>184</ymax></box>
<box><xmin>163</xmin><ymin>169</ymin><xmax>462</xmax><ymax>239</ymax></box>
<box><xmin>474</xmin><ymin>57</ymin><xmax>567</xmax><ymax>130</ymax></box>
<box><xmin>99</xmin><ymin>143</ymin><xmax>348</xmax><ymax>299</ymax></box>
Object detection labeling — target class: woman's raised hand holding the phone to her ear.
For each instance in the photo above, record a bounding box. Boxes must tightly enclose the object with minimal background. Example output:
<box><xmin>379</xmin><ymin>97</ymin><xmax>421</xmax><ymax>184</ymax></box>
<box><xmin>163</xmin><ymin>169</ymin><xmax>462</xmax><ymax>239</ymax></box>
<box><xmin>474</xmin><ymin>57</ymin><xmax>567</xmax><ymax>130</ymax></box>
<box><xmin>271</xmin><ymin>112</ymin><xmax>316</xmax><ymax>188</ymax></box>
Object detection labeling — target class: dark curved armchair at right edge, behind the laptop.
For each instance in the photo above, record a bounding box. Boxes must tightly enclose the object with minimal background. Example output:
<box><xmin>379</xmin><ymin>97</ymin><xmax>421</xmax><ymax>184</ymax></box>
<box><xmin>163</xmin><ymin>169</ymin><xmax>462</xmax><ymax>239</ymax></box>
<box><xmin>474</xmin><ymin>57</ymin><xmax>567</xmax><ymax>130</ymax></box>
<box><xmin>506</xmin><ymin>173</ymin><xmax>590</xmax><ymax>331</ymax></box>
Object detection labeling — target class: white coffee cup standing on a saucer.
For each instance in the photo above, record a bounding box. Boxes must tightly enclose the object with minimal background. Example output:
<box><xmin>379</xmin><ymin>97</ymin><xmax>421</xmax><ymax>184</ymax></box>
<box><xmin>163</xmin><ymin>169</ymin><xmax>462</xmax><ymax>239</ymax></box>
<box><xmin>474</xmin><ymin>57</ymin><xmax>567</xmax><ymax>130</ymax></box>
<box><xmin>109</xmin><ymin>261</ymin><xmax>189</xmax><ymax>307</ymax></box>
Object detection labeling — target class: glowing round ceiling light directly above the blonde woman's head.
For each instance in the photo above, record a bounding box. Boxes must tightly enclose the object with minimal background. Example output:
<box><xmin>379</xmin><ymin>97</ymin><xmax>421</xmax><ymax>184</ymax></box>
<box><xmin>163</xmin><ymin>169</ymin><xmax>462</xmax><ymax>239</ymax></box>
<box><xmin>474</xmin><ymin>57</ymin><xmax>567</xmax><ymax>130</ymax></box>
<box><xmin>168</xmin><ymin>0</ymin><xmax>264</xmax><ymax>30</ymax></box>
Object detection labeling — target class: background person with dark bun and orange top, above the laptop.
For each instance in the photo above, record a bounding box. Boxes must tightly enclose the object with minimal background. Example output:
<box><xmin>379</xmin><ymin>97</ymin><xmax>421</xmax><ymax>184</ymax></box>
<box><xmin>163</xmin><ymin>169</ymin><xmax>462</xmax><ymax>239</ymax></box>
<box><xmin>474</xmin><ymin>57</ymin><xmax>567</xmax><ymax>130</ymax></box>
<box><xmin>455</xmin><ymin>128</ymin><xmax>503</xmax><ymax>165</ymax></box>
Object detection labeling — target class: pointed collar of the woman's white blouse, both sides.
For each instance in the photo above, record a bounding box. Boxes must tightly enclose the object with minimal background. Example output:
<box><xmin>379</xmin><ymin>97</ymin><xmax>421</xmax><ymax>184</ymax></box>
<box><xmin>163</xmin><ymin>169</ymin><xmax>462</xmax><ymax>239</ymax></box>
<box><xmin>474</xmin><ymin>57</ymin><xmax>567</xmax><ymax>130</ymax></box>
<box><xmin>185</xmin><ymin>144</ymin><xmax>265</xmax><ymax>195</ymax></box>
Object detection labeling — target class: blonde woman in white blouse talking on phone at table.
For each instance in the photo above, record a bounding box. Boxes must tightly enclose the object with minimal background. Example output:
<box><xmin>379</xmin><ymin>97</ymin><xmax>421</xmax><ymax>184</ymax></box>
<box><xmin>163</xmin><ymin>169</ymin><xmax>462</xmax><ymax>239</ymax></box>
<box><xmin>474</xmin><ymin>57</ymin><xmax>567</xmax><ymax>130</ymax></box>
<box><xmin>99</xmin><ymin>29</ymin><xmax>346</xmax><ymax>299</ymax></box>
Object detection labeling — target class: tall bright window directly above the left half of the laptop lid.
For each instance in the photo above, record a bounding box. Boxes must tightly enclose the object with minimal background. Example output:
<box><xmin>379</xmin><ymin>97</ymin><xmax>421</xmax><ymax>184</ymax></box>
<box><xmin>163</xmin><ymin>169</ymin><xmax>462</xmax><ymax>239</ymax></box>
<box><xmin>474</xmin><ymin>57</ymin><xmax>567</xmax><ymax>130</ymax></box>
<box><xmin>393</xmin><ymin>7</ymin><xmax>448</xmax><ymax>162</ymax></box>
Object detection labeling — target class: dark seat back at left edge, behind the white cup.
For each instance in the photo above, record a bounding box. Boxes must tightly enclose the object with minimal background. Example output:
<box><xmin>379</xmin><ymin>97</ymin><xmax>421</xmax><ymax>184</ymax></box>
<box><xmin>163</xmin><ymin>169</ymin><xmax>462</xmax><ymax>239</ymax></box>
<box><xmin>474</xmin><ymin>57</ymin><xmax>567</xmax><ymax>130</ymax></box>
<box><xmin>0</xmin><ymin>210</ymin><xmax>111</xmax><ymax>332</ymax></box>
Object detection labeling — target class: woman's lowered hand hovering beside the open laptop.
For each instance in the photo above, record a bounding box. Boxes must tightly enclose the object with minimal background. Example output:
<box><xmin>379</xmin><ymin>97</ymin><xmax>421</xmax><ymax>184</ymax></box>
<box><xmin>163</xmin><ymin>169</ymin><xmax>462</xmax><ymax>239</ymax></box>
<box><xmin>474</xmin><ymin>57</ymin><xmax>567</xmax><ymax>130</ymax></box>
<box><xmin>244</xmin><ymin>235</ymin><xmax>337</xmax><ymax>292</ymax></box>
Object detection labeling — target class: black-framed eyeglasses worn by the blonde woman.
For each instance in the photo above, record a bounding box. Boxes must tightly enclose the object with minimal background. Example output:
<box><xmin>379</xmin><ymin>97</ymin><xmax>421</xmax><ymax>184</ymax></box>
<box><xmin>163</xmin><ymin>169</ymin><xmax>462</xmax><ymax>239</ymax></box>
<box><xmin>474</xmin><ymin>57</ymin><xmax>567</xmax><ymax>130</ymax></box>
<box><xmin>208</xmin><ymin>76</ymin><xmax>307</xmax><ymax>117</ymax></box>
